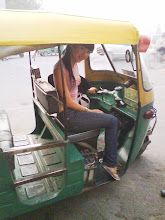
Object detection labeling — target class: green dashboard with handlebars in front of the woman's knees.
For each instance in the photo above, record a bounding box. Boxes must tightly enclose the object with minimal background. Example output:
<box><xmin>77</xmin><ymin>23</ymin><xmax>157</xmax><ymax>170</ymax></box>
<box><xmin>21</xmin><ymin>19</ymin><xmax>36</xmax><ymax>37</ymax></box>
<box><xmin>89</xmin><ymin>86</ymin><xmax>138</xmax><ymax>121</ymax></box>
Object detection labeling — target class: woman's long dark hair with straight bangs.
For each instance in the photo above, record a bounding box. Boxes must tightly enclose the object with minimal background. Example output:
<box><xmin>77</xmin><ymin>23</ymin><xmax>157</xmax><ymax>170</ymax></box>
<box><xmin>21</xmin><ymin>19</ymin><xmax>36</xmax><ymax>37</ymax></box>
<box><xmin>62</xmin><ymin>44</ymin><xmax>94</xmax><ymax>85</ymax></box>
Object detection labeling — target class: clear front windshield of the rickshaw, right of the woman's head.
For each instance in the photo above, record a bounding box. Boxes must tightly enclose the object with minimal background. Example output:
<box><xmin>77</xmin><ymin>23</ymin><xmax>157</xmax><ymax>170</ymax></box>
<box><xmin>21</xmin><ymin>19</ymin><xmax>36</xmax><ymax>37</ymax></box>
<box><xmin>90</xmin><ymin>44</ymin><xmax>136</xmax><ymax>77</ymax></box>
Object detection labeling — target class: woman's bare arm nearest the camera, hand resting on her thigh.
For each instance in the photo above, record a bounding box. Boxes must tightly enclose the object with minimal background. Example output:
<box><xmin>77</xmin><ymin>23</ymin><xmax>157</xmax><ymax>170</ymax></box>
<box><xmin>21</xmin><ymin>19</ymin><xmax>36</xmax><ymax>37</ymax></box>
<box><xmin>53</xmin><ymin>69</ymin><xmax>102</xmax><ymax>113</ymax></box>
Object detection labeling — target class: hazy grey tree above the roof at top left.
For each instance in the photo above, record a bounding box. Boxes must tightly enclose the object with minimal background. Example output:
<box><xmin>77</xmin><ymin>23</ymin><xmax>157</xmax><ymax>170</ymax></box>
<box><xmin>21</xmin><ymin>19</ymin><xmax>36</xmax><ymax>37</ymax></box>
<box><xmin>6</xmin><ymin>0</ymin><xmax>43</xmax><ymax>10</ymax></box>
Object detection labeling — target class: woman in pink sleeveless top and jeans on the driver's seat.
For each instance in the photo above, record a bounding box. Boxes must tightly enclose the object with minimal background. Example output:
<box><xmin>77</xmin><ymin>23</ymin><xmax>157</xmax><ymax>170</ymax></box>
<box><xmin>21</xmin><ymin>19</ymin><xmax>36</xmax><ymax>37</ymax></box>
<box><xmin>53</xmin><ymin>44</ymin><xmax>120</xmax><ymax>180</ymax></box>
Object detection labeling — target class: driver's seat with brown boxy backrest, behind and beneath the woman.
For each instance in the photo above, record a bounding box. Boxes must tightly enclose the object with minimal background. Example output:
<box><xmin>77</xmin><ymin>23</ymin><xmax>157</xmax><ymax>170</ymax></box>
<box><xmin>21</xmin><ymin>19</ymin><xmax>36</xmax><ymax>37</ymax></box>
<box><xmin>34</xmin><ymin>80</ymin><xmax>100</xmax><ymax>143</ymax></box>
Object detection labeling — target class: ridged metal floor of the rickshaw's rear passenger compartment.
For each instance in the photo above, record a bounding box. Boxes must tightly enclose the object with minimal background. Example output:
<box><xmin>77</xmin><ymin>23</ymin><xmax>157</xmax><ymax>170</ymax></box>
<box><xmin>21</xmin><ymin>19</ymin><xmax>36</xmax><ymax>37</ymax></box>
<box><xmin>13</xmin><ymin>135</ymin><xmax>65</xmax><ymax>200</ymax></box>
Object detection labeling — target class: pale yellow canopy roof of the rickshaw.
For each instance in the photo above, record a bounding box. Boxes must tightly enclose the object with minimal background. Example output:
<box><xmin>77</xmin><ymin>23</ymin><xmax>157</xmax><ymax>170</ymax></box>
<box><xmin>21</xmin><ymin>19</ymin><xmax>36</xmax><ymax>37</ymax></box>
<box><xmin>0</xmin><ymin>10</ymin><xmax>139</xmax><ymax>46</ymax></box>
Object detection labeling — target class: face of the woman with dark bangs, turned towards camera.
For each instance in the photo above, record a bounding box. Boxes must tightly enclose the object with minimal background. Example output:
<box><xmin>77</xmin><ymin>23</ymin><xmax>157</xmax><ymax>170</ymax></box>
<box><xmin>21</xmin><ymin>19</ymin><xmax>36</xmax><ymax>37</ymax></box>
<box><xmin>71</xmin><ymin>45</ymin><xmax>91</xmax><ymax>63</ymax></box>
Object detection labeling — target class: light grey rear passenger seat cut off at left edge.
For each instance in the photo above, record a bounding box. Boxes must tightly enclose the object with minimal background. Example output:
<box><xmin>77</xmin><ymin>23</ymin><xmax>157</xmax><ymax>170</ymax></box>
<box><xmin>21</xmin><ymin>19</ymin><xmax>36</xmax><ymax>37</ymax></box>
<box><xmin>0</xmin><ymin>110</ymin><xmax>14</xmax><ymax>170</ymax></box>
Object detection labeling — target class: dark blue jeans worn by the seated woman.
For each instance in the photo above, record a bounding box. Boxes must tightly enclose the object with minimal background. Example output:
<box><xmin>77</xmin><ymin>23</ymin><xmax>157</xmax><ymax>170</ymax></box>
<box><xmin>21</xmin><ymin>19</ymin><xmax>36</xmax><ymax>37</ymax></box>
<box><xmin>58</xmin><ymin>109</ymin><xmax>119</xmax><ymax>167</ymax></box>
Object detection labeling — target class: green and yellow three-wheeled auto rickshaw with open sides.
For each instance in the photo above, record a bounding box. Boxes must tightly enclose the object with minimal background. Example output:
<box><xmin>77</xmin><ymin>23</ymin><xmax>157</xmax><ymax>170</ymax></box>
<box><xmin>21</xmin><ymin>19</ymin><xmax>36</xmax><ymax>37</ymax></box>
<box><xmin>0</xmin><ymin>10</ymin><xmax>156</xmax><ymax>218</ymax></box>
